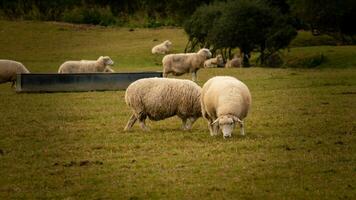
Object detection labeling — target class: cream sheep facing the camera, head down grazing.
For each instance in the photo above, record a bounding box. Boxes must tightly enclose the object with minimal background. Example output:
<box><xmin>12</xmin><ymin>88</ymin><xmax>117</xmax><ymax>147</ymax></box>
<box><xmin>200</xmin><ymin>76</ymin><xmax>251</xmax><ymax>138</ymax></box>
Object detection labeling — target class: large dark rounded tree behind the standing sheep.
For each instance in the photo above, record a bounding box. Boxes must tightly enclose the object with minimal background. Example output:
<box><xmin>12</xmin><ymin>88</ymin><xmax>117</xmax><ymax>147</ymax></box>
<box><xmin>185</xmin><ymin>0</ymin><xmax>296</xmax><ymax>66</ymax></box>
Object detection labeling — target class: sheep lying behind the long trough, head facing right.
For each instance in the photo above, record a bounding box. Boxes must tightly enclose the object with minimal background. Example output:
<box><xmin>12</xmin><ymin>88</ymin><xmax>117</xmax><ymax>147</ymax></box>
<box><xmin>58</xmin><ymin>56</ymin><xmax>114</xmax><ymax>73</ymax></box>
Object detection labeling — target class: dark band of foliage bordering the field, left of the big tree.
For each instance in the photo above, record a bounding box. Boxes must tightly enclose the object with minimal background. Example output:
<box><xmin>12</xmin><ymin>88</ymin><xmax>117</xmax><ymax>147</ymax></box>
<box><xmin>0</xmin><ymin>0</ymin><xmax>213</xmax><ymax>25</ymax></box>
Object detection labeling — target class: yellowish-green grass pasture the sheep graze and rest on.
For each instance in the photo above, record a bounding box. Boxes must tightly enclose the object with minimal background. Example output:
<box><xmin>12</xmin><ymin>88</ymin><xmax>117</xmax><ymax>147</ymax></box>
<box><xmin>0</xmin><ymin>21</ymin><xmax>356</xmax><ymax>199</ymax></box>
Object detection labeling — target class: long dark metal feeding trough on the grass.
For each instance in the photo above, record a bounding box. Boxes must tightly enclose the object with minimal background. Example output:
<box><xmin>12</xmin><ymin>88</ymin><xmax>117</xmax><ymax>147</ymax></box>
<box><xmin>16</xmin><ymin>72</ymin><xmax>162</xmax><ymax>92</ymax></box>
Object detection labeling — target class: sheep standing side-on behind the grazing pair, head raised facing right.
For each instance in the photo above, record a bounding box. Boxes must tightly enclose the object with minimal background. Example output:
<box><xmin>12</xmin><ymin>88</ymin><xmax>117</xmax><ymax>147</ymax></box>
<box><xmin>162</xmin><ymin>48</ymin><xmax>211</xmax><ymax>82</ymax></box>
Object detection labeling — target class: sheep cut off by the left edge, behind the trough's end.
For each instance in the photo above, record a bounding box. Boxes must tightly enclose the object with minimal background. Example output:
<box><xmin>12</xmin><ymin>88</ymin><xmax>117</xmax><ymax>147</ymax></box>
<box><xmin>0</xmin><ymin>60</ymin><xmax>30</xmax><ymax>87</ymax></box>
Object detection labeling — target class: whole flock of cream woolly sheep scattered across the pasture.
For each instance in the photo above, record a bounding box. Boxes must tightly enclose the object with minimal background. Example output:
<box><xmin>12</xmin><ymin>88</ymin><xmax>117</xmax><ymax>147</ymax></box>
<box><xmin>0</xmin><ymin>40</ymin><xmax>251</xmax><ymax>138</ymax></box>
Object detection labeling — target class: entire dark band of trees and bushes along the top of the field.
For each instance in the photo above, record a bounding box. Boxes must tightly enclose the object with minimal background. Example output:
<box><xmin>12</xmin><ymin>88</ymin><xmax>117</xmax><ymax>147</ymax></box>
<box><xmin>0</xmin><ymin>0</ymin><xmax>356</xmax><ymax>67</ymax></box>
